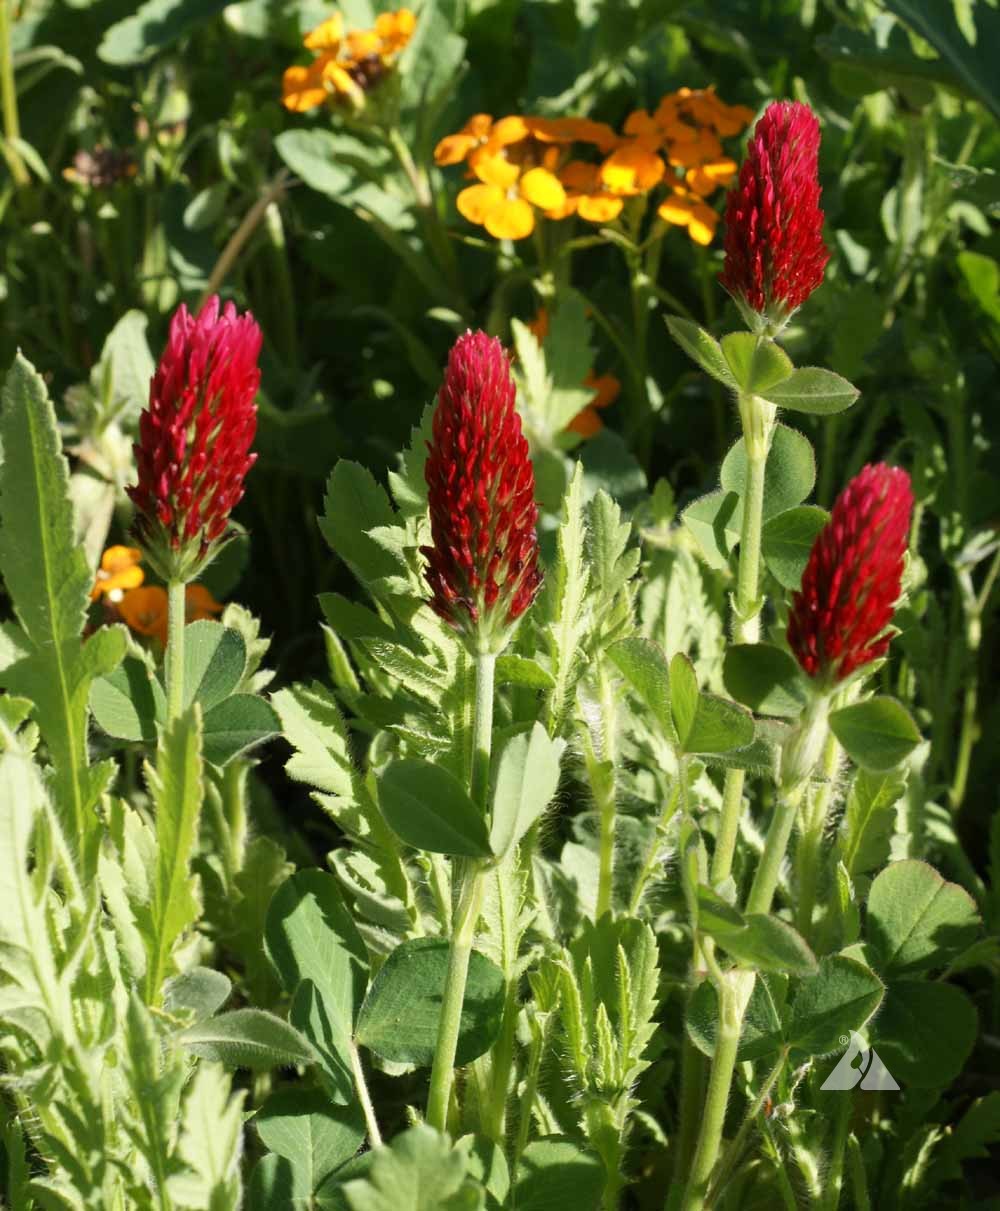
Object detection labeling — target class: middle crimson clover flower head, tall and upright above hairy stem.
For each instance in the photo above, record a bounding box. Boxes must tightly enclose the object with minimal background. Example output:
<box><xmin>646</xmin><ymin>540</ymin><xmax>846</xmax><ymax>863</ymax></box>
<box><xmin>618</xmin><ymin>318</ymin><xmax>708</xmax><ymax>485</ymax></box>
<box><xmin>421</xmin><ymin>332</ymin><xmax>541</xmax><ymax>653</ymax></box>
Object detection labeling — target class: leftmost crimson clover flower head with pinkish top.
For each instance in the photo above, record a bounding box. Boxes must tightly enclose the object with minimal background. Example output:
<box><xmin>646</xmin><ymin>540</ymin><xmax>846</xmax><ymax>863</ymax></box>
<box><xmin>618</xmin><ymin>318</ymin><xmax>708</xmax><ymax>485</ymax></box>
<box><xmin>127</xmin><ymin>295</ymin><xmax>262</xmax><ymax>581</ymax></box>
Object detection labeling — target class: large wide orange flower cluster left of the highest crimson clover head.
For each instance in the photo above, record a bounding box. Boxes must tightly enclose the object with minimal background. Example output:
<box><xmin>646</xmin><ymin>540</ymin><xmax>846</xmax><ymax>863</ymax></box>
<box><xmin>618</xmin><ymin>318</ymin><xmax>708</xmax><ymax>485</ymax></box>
<box><xmin>435</xmin><ymin>88</ymin><xmax>753</xmax><ymax>243</ymax></box>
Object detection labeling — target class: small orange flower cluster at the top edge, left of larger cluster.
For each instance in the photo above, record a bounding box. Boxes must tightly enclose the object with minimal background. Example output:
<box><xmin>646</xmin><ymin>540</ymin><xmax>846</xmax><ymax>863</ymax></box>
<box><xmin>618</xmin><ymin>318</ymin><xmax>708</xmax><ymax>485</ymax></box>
<box><xmin>281</xmin><ymin>8</ymin><xmax>416</xmax><ymax>114</ymax></box>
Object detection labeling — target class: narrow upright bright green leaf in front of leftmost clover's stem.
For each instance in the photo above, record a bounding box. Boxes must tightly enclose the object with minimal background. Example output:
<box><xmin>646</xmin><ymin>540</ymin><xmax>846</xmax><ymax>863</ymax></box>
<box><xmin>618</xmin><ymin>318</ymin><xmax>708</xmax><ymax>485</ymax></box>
<box><xmin>145</xmin><ymin>707</ymin><xmax>203</xmax><ymax>1004</ymax></box>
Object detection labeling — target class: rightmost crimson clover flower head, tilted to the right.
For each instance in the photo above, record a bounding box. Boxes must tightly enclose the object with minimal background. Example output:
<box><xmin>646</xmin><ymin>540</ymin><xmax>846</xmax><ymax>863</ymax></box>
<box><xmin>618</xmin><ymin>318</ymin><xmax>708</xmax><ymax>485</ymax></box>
<box><xmin>787</xmin><ymin>463</ymin><xmax>913</xmax><ymax>685</ymax></box>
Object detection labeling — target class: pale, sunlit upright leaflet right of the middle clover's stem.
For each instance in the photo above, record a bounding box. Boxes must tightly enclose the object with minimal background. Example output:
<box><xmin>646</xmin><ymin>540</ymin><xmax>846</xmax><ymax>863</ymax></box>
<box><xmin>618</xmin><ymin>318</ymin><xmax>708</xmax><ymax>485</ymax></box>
<box><xmin>489</xmin><ymin>722</ymin><xmax>565</xmax><ymax>857</ymax></box>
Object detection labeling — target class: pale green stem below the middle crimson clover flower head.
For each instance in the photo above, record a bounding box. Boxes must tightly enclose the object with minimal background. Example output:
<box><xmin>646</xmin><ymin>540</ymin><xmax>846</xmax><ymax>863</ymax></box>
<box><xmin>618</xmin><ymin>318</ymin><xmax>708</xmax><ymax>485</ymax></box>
<box><xmin>426</xmin><ymin>652</ymin><xmax>496</xmax><ymax>1131</ymax></box>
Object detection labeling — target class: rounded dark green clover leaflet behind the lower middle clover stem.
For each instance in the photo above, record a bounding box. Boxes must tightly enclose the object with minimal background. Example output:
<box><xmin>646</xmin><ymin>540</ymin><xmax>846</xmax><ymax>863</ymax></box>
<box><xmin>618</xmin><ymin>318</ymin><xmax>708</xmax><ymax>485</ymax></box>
<box><xmin>355</xmin><ymin>937</ymin><xmax>505</xmax><ymax>1067</ymax></box>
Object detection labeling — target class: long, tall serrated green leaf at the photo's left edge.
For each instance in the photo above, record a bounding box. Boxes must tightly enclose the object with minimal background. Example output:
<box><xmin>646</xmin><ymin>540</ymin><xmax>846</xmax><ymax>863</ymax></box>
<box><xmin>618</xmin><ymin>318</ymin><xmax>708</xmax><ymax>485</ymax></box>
<box><xmin>0</xmin><ymin>354</ymin><xmax>125</xmax><ymax>882</ymax></box>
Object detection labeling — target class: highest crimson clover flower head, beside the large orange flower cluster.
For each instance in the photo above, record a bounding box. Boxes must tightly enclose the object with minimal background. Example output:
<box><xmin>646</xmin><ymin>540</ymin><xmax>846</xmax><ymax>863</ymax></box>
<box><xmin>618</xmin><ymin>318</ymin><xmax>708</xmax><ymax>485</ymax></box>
<box><xmin>719</xmin><ymin>101</ymin><xmax>829</xmax><ymax>333</ymax></box>
